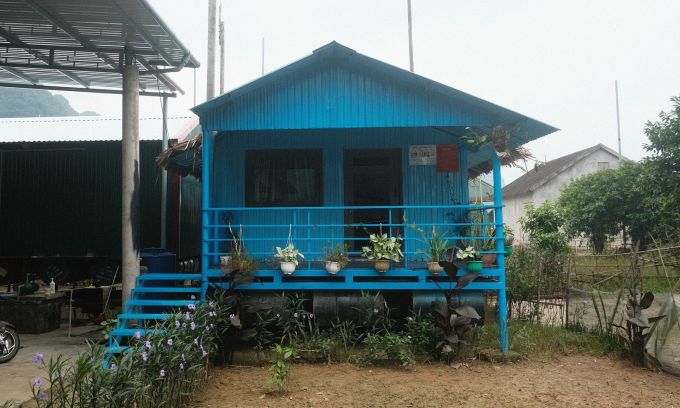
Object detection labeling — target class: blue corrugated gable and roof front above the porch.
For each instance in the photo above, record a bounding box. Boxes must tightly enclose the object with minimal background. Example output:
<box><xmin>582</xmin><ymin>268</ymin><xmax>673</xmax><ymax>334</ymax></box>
<box><xmin>193</xmin><ymin>42</ymin><xmax>557</xmax><ymax>144</ymax></box>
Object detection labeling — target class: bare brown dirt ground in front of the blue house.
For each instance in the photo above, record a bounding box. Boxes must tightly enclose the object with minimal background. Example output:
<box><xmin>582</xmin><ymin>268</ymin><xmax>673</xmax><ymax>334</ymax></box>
<box><xmin>192</xmin><ymin>355</ymin><xmax>680</xmax><ymax>407</ymax></box>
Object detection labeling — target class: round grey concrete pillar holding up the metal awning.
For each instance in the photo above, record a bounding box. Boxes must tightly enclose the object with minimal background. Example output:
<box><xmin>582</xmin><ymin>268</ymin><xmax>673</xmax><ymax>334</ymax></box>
<box><xmin>121</xmin><ymin>60</ymin><xmax>140</xmax><ymax>301</ymax></box>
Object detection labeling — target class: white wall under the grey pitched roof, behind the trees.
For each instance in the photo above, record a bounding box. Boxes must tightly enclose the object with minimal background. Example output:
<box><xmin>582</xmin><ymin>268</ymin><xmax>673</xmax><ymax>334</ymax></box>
<box><xmin>503</xmin><ymin>149</ymin><xmax>619</xmax><ymax>241</ymax></box>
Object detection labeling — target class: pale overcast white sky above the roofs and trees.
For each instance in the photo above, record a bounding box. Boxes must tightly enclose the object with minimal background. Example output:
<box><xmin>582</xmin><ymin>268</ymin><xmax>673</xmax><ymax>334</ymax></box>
<box><xmin>58</xmin><ymin>0</ymin><xmax>680</xmax><ymax>183</ymax></box>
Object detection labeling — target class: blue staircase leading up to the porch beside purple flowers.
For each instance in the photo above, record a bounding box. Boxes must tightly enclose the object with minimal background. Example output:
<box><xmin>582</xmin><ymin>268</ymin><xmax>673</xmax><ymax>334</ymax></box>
<box><xmin>104</xmin><ymin>273</ymin><xmax>201</xmax><ymax>356</ymax></box>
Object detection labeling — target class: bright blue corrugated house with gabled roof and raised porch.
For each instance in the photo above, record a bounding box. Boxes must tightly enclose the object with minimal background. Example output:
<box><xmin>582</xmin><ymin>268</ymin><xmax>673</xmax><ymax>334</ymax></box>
<box><xmin>193</xmin><ymin>42</ymin><xmax>556</xmax><ymax>349</ymax></box>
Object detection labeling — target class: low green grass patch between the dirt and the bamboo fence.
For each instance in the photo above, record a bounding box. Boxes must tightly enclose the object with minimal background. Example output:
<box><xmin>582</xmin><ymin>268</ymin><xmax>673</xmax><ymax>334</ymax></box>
<box><xmin>473</xmin><ymin>321</ymin><xmax>620</xmax><ymax>359</ymax></box>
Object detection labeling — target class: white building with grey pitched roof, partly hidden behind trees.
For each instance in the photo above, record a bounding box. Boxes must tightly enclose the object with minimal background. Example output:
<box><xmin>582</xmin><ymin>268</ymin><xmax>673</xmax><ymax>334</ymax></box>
<box><xmin>503</xmin><ymin>144</ymin><xmax>625</xmax><ymax>241</ymax></box>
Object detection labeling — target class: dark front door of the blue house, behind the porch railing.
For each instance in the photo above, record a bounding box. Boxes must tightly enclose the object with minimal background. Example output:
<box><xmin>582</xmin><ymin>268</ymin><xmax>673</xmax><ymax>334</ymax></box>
<box><xmin>344</xmin><ymin>149</ymin><xmax>402</xmax><ymax>251</ymax></box>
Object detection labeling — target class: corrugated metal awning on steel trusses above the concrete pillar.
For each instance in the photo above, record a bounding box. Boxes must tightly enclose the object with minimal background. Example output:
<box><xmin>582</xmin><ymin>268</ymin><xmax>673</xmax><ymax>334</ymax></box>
<box><xmin>0</xmin><ymin>0</ymin><xmax>199</xmax><ymax>96</ymax></box>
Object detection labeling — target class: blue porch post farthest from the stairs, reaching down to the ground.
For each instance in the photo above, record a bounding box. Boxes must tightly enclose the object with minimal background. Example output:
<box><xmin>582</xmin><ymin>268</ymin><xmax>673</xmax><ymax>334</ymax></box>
<box><xmin>493</xmin><ymin>152</ymin><xmax>508</xmax><ymax>353</ymax></box>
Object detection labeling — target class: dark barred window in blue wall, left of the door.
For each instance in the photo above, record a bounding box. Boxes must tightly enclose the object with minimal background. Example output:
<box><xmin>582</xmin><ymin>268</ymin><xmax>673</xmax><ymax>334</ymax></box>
<box><xmin>245</xmin><ymin>149</ymin><xmax>323</xmax><ymax>207</ymax></box>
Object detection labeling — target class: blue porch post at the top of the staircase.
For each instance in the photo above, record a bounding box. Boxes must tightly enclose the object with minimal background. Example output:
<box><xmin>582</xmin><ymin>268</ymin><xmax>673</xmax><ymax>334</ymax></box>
<box><xmin>201</xmin><ymin>131</ymin><xmax>213</xmax><ymax>299</ymax></box>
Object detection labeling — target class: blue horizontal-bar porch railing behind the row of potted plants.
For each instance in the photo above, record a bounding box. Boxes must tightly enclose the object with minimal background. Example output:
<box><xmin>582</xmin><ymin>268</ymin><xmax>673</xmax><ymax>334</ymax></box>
<box><xmin>203</xmin><ymin>205</ymin><xmax>504</xmax><ymax>290</ymax></box>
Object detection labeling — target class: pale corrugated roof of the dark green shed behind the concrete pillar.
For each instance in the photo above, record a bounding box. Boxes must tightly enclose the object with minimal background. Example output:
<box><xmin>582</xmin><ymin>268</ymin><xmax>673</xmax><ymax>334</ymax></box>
<box><xmin>0</xmin><ymin>115</ymin><xmax>196</xmax><ymax>143</ymax></box>
